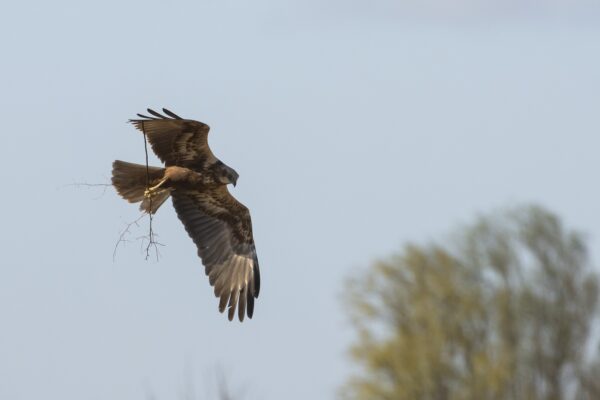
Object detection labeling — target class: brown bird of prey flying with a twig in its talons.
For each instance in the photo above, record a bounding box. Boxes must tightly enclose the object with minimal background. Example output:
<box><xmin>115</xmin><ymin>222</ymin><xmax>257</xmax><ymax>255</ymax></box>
<box><xmin>112</xmin><ymin>108</ymin><xmax>260</xmax><ymax>321</ymax></box>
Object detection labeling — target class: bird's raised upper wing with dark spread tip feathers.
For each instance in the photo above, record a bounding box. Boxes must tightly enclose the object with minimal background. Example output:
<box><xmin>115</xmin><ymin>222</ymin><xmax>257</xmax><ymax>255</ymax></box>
<box><xmin>129</xmin><ymin>108</ymin><xmax>217</xmax><ymax>169</ymax></box>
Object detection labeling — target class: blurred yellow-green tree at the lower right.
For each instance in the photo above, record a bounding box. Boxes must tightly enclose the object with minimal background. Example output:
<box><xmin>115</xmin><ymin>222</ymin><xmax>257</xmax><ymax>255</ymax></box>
<box><xmin>341</xmin><ymin>206</ymin><xmax>600</xmax><ymax>400</ymax></box>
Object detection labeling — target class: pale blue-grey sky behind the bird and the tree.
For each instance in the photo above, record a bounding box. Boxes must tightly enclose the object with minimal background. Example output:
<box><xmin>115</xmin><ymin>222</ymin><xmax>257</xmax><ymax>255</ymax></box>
<box><xmin>0</xmin><ymin>0</ymin><xmax>600</xmax><ymax>400</ymax></box>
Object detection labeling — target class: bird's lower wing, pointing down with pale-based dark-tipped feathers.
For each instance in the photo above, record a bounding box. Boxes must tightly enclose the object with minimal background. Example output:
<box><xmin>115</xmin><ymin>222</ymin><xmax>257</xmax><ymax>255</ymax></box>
<box><xmin>172</xmin><ymin>186</ymin><xmax>260</xmax><ymax>321</ymax></box>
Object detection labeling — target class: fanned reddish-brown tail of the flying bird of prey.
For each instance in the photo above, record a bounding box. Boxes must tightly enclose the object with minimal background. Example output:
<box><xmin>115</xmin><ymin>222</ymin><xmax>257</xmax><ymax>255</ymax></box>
<box><xmin>112</xmin><ymin>160</ymin><xmax>171</xmax><ymax>214</ymax></box>
